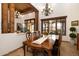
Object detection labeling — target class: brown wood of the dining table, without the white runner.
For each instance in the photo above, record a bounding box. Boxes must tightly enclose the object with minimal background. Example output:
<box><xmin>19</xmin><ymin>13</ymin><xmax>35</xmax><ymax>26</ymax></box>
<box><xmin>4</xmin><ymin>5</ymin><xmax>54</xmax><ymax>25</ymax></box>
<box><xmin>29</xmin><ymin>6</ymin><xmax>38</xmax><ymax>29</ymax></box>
<box><xmin>23</xmin><ymin>38</ymin><xmax>54</xmax><ymax>56</ymax></box>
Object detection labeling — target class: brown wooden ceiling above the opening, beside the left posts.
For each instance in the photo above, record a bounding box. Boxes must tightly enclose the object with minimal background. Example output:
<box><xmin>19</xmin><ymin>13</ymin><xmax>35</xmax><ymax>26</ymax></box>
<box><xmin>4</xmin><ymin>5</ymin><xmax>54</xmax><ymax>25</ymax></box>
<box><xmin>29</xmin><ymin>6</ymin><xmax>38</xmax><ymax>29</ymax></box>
<box><xmin>8</xmin><ymin>3</ymin><xmax>38</xmax><ymax>14</ymax></box>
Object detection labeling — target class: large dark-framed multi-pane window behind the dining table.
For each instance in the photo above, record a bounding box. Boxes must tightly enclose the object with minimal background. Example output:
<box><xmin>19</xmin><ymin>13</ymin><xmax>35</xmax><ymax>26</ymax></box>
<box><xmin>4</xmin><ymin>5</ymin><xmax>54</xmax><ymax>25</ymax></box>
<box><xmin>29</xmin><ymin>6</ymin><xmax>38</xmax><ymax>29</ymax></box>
<box><xmin>41</xmin><ymin>16</ymin><xmax>67</xmax><ymax>35</ymax></box>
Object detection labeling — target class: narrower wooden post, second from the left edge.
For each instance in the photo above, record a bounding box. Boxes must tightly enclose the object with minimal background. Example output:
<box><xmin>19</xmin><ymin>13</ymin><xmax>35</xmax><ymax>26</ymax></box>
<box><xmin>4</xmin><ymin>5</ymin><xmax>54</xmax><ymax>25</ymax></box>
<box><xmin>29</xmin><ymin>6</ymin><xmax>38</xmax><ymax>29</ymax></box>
<box><xmin>9</xmin><ymin>3</ymin><xmax>15</xmax><ymax>33</ymax></box>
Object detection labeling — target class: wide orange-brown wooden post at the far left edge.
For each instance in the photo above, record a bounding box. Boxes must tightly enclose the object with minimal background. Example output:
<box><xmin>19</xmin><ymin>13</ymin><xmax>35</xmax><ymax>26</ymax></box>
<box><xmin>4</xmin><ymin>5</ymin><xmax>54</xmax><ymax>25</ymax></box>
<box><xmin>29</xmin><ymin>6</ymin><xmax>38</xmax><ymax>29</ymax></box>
<box><xmin>2</xmin><ymin>3</ymin><xmax>8</xmax><ymax>33</ymax></box>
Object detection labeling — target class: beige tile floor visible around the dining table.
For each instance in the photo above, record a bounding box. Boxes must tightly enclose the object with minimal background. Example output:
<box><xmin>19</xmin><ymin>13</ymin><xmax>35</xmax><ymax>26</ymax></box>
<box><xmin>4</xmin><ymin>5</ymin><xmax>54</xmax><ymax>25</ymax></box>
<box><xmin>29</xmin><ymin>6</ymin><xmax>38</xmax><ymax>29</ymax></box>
<box><xmin>7</xmin><ymin>42</ymin><xmax>79</xmax><ymax>56</ymax></box>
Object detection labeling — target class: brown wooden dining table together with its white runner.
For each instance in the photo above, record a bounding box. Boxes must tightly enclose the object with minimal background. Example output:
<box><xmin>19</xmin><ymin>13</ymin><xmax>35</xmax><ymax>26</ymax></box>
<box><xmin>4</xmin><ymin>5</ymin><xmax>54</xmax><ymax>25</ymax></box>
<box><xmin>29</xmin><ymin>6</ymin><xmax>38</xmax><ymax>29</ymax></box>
<box><xmin>23</xmin><ymin>36</ymin><xmax>54</xmax><ymax>56</ymax></box>
